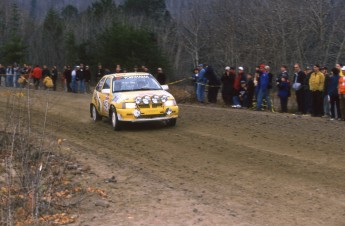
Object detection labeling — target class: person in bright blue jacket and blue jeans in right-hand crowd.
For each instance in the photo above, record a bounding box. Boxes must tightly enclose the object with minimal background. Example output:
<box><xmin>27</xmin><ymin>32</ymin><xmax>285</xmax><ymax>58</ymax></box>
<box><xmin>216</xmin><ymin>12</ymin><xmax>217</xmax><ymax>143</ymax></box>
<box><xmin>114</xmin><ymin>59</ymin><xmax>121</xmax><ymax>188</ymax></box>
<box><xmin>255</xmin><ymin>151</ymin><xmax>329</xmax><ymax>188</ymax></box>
<box><xmin>256</xmin><ymin>64</ymin><xmax>271</xmax><ymax>111</ymax></box>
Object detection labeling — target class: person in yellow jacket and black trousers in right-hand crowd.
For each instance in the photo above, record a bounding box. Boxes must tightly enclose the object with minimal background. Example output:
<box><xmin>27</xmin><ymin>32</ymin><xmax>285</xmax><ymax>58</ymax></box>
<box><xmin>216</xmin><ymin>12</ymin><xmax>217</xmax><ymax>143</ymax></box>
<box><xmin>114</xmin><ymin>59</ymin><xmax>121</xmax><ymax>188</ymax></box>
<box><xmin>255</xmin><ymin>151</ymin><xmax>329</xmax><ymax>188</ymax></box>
<box><xmin>309</xmin><ymin>64</ymin><xmax>325</xmax><ymax>117</ymax></box>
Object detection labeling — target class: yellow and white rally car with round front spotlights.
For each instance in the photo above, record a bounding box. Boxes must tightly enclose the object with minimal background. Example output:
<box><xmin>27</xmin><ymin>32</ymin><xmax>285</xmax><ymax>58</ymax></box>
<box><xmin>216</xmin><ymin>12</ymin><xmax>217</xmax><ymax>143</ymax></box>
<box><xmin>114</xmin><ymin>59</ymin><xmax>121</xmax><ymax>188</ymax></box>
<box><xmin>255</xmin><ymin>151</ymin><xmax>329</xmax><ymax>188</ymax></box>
<box><xmin>90</xmin><ymin>72</ymin><xmax>179</xmax><ymax>130</ymax></box>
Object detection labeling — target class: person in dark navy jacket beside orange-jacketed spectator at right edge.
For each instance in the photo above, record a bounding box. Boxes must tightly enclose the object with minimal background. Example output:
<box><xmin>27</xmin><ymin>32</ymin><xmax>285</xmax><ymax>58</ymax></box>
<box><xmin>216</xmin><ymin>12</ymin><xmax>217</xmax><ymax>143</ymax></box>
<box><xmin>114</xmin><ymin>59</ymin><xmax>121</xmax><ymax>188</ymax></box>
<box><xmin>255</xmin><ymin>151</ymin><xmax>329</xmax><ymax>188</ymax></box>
<box><xmin>327</xmin><ymin>68</ymin><xmax>341</xmax><ymax>120</ymax></box>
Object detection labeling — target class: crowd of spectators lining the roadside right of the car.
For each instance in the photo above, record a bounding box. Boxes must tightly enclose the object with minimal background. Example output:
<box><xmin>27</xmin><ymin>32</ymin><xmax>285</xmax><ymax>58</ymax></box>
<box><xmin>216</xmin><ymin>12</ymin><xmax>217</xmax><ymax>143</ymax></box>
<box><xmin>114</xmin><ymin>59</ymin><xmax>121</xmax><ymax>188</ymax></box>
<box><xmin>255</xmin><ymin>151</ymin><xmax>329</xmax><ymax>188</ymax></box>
<box><xmin>192</xmin><ymin>64</ymin><xmax>345</xmax><ymax>120</ymax></box>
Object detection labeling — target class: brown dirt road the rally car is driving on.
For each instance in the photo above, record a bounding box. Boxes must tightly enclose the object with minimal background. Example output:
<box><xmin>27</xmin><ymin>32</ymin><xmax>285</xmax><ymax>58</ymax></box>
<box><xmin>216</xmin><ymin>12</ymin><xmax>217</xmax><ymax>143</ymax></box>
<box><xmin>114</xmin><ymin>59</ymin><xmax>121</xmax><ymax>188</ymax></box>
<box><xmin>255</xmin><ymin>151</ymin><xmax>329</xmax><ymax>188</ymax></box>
<box><xmin>0</xmin><ymin>89</ymin><xmax>345</xmax><ymax>226</ymax></box>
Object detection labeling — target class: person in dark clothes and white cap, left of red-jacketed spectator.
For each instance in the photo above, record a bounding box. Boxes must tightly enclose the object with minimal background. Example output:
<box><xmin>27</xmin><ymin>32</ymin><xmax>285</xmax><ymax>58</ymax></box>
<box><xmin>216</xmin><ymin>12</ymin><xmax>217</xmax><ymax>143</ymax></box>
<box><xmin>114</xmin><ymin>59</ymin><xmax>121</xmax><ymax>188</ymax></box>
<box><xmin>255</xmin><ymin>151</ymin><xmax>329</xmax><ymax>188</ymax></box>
<box><xmin>221</xmin><ymin>67</ymin><xmax>236</xmax><ymax>106</ymax></box>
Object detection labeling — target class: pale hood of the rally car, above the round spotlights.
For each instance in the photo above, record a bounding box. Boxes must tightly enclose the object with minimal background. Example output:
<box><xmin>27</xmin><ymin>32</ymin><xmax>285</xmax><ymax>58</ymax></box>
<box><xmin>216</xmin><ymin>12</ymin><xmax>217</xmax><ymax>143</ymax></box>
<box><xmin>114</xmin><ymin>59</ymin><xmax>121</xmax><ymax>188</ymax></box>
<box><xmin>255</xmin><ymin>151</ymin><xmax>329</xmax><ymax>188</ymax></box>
<box><xmin>113</xmin><ymin>90</ymin><xmax>174</xmax><ymax>103</ymax></box>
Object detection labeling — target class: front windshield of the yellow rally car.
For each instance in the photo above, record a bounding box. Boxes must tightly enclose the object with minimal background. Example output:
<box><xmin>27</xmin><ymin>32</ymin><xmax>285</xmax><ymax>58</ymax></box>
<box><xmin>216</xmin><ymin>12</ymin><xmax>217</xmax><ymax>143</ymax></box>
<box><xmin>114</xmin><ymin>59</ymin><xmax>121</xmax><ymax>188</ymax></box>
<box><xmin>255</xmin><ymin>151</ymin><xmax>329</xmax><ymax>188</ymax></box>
<box><xmin>113</xmin><ymin>75</ymin><xmax>162</xmax><ymax>93</ymax></box>
